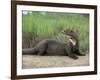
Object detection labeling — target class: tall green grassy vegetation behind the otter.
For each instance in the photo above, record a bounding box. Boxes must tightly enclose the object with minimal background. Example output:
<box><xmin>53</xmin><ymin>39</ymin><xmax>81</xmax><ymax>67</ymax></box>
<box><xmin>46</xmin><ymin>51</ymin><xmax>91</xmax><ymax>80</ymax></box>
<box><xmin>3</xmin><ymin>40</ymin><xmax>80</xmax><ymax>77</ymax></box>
<box><xmin>22</xmin><ymin>11</ymin><xmax>89</xmax><ymax>51</ymax></box>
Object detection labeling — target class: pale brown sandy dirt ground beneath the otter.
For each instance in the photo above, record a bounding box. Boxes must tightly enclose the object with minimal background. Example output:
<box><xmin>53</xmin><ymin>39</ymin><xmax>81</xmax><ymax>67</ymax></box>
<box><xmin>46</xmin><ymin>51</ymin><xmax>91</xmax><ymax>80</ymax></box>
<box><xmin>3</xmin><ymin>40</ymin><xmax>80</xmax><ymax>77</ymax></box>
<box><xmin>22</xmin><ymin>55</ymin><xmax>89</xmax><ymax>69</ymax></box>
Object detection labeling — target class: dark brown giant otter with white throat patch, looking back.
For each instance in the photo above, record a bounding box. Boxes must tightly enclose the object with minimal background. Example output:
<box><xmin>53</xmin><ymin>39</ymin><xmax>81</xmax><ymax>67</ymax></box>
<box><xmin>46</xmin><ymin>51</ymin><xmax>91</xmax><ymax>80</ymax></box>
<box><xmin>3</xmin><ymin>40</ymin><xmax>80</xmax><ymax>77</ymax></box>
<box><xmin>22</xmin><ymin>29</ymin><xmax>84</xmax><ymax>59</ymax></box>
